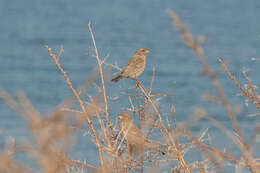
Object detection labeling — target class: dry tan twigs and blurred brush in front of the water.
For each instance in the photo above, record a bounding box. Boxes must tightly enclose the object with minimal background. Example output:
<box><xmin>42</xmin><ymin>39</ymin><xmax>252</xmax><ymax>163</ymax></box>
<box><xmin>0</xmin><ymin>10</ymin><xmax>260</xmax><ymax>173</ymax></box>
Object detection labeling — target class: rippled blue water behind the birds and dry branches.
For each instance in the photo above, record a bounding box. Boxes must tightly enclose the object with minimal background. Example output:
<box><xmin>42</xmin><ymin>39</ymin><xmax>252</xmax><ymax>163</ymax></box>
<box><xmin>0</xmin><ymin>0</ymin><xmax>260</xmax><ymax>170</ymax></box>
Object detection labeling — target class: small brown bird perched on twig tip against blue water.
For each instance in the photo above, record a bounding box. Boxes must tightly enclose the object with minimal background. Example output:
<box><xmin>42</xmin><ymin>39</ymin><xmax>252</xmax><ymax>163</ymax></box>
<box><xmin>112</xmin><ymin>48</ymin><xmax>150</xmax><ymax>82</ymax></box>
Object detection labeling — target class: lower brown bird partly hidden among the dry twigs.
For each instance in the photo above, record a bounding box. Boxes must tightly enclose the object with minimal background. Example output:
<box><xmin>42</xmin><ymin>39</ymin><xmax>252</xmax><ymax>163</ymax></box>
<box><xmin>119</xmin><ymin>112</ymin><xmax>165</xmax><ymax>155</ymax></box>
